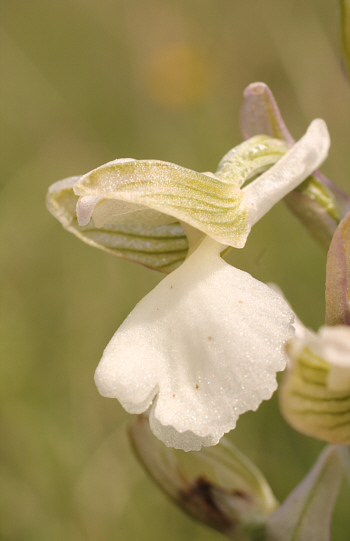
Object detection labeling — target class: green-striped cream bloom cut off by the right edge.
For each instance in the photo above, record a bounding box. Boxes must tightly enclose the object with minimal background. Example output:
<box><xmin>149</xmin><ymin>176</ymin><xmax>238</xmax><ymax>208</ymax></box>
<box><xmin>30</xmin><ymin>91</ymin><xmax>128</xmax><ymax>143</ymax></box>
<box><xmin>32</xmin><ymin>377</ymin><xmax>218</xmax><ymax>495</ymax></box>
<box><xmin>280</xmin><ymin>325</ymin><xmax>350</xmax><ymax>444</ymax></box>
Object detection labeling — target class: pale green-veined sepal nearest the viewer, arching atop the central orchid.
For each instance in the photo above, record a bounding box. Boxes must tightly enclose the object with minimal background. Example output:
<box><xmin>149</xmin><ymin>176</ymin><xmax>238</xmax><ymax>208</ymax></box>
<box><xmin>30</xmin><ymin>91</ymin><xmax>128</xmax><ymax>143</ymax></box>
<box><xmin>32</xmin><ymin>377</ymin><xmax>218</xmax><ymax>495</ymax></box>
<box><xmin>74</xmin><ymin>160</ymin><xmax>254</xmax><ymax>248</ymax></box>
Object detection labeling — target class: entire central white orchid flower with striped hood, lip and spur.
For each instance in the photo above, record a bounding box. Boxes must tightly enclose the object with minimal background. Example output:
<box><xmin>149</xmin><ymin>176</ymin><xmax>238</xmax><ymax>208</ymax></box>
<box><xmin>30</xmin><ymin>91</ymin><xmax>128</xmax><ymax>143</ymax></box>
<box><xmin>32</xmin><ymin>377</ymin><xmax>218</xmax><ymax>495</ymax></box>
<box><xmin>48</xmin><ymin>120</ymin><xmax>329</xmax><ymax>451</ymax></box>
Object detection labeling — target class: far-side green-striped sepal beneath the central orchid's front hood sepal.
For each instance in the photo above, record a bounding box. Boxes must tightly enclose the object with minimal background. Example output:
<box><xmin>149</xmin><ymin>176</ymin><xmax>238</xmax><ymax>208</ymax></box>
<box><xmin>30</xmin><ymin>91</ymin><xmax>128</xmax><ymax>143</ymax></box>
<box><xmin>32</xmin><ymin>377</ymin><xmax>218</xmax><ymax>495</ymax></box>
<box><xmin>47</xmin><ymin>177</ymin><xmax>188</xmax><ymax>272</ymax></box>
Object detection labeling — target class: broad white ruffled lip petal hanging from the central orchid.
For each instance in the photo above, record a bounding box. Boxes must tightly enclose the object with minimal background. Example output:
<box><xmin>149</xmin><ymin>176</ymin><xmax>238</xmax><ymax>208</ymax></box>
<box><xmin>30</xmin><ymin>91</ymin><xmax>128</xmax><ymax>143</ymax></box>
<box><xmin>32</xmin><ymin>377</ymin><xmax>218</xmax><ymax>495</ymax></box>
<box><xmin>95</xmin><ymin>238</ymin><xmax>293</xmax><ymax>451</ymax></box>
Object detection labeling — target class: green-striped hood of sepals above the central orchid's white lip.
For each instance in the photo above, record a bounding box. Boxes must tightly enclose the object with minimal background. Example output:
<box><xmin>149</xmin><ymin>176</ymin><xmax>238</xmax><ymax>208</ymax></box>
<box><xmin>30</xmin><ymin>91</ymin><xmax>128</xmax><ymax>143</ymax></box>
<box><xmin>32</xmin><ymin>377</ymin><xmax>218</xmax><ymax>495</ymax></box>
<box><xmin>47</xmin><ymin>136</ymin><xmax>287</xmax><ymax>272</ymax></box>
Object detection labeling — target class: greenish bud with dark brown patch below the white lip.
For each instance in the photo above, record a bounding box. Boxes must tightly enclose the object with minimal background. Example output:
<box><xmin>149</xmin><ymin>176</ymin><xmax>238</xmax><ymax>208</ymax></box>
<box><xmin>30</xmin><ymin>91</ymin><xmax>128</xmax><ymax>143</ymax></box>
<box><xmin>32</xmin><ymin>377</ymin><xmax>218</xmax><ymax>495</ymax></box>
<box><xmin>129</xmin><ymin>415</ymin><xmax>277</xmax><ymax>541</ymax></box>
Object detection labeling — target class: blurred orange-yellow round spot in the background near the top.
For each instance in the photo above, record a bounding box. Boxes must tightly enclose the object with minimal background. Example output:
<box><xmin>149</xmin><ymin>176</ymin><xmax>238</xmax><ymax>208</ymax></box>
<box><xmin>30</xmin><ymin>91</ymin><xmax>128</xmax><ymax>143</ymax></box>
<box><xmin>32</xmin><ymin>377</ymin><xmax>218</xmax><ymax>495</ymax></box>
<box><xmin>146</xmin><ymin>43</ymin><xmax>212</xmax><ymax>109</ymax></box>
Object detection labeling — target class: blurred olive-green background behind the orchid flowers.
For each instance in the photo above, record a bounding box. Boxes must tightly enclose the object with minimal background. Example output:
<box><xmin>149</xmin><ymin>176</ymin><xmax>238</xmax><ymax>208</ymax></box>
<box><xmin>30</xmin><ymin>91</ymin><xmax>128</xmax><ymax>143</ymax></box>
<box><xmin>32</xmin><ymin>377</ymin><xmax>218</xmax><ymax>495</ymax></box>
<box><xmin>0</xmin><ymin>0</ymin><xmax>350</xmax><ymax>541</ymax></box>
